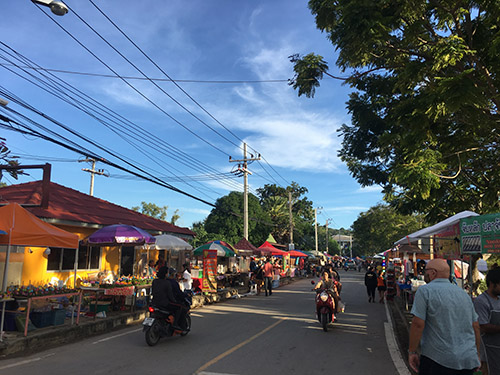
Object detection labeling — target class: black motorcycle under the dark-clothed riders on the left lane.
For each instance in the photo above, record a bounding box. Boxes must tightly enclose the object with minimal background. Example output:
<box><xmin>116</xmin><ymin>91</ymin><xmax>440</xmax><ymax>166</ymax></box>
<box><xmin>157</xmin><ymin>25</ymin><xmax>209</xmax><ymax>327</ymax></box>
<box><xmin>142</xmin><ymin>291</ymin><xmax>192</xmax><ymax>346</ymax></box>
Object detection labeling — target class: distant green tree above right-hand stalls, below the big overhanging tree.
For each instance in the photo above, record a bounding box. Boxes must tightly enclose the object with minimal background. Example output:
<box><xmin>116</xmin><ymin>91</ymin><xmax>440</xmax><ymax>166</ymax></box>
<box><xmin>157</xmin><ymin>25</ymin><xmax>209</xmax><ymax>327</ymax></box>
<box><xmin>352</xmin><ymin>204</ymin><xmax>423</xmax><ymax>255</ymax></box>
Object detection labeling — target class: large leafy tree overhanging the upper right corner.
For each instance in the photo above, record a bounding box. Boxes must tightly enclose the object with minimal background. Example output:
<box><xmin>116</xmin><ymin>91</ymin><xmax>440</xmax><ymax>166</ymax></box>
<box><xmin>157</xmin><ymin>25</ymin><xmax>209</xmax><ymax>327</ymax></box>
<box><xmin>291</xmin><ymin>0</ymin><xmax>500</xmax><ymax>222</ymax></box>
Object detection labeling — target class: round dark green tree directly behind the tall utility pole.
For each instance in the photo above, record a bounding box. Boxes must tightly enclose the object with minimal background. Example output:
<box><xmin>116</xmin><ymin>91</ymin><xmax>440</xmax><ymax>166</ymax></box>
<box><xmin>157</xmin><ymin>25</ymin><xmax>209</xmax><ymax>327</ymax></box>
<box><xmin>205</xmin><ymin>191</ymin><xmax>272</xmax><ymax>246</ymax></box>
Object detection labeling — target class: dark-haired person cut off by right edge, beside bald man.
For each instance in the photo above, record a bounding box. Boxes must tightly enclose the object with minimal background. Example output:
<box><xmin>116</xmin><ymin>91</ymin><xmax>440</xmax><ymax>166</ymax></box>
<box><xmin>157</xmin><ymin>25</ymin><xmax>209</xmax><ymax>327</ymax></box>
<box><xmin>474</xmin><ymin>268</ymin><xmax>500</xmax><ymax>375</ymax></box>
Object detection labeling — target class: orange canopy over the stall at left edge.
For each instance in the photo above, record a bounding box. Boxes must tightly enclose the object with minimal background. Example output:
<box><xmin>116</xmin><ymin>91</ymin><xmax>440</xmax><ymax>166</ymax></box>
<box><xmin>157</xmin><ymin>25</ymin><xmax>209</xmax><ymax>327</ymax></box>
<box><xmin>0</xmin><ymin>203</ymin><xmax>78</xmax><ymax>249</ymax></box>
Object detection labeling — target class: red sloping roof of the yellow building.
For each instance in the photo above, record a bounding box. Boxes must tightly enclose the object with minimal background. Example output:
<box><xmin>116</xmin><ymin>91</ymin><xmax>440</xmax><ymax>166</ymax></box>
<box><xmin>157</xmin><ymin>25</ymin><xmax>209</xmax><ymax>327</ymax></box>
<box><xmin>0</xmin><ymin>181</ymin><xmax>195</xmax><ymax>236</ymax></box>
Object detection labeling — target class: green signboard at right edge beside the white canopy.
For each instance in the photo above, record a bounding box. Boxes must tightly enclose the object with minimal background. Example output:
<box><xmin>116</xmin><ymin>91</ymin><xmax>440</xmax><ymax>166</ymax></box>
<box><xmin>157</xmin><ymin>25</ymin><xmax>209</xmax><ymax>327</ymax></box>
<box><xmin>460</xmin><ymin>213</ymin><xmax>500</xmax><ymax>254</ymax></box>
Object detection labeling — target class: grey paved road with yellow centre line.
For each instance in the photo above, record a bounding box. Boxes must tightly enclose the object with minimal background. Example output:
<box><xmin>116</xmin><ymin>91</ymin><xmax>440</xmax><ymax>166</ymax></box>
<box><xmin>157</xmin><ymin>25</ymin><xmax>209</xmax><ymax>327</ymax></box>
<box><xmin>0</xmin><ymin>271</ymin><xmax>404</xmax><ymax>375</ymax></box>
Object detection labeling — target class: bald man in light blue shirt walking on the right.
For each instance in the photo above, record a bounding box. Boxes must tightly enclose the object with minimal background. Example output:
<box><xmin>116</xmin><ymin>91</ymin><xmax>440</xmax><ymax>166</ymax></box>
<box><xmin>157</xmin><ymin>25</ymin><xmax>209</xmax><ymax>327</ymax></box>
<box><xmin>408</xmin><ymin>259</ymin><xmax>480</xmax><ymax>375</ymax></box>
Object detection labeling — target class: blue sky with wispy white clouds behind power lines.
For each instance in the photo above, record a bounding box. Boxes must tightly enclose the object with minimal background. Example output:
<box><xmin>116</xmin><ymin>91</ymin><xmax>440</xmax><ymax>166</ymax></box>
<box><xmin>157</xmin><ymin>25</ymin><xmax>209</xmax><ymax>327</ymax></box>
<box><xmin>0</xmin><ymin>0</ymin><xmax>382</xmax><ymax>232</ymax></box>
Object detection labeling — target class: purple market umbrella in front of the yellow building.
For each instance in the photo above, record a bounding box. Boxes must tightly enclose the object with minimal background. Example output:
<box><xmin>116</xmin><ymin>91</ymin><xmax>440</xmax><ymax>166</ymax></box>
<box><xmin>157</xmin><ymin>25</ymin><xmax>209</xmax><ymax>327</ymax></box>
<box><xmin>86</xmin><ymin>224</ymin><xmax>156</xmax><ymax>245</ymax></box>
